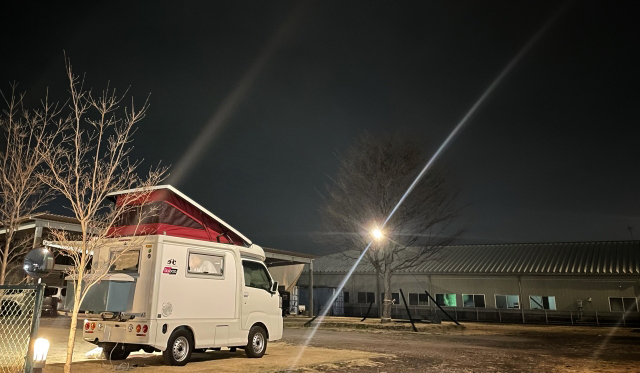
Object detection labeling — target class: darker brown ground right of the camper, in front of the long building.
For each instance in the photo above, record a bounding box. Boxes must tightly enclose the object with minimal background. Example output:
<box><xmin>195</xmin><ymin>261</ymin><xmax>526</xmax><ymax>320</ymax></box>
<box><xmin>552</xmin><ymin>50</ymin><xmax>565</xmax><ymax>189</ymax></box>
<box><xmin>283</xmin><ymin>323</ymin><xmax>640</xmax><ymax>373</ymax></box>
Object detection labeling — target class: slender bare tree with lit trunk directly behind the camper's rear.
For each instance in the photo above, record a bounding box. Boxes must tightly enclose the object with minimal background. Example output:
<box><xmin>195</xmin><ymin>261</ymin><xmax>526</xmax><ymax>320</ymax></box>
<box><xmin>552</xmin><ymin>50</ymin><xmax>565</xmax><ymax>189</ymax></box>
<box><xmin>36</xmin><ymin>60</ymin><xmax>166</xmax><ymax>373</ymax></box>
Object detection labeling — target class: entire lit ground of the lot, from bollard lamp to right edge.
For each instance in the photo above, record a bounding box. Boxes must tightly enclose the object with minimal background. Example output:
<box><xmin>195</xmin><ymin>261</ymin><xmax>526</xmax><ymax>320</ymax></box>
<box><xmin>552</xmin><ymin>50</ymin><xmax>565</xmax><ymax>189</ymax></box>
<box><xmin>33</xmin><ymin>317</ymin><xmax>640</xmax><ymax>373</ymax></box>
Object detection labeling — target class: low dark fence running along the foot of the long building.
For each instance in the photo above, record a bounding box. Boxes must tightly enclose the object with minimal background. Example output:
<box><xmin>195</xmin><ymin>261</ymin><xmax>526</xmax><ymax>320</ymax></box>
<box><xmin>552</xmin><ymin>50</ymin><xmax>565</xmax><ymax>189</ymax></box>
<box><xmin>344</xmin><ymin>304</ymin><xmax>640</xmax><ymax>327</ymax></box>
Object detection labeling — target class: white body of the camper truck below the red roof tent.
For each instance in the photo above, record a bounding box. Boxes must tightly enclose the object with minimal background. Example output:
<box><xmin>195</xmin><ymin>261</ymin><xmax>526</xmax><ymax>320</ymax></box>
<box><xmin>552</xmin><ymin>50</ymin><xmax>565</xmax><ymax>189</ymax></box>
<box><xmin>82</xmin><ymin>235</ymin><xmax>283</xmax><ymax>354</ymax></box>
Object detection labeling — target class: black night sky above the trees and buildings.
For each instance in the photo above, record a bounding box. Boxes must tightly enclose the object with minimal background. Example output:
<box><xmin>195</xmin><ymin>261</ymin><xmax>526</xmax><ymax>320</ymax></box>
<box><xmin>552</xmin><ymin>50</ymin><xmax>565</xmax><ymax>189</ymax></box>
<box><xmin>0</xmin><ymin>0</ymin><xmax>640</xmax><ymax>253</ymax></box>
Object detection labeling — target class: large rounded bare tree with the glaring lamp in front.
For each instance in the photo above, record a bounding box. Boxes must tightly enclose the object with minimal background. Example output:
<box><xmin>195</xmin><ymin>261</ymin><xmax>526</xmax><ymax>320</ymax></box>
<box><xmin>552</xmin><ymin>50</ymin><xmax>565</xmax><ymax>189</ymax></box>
<box><xmin>320</xmin><ymin>133</ymin><xmax>462</xmax><ymax>322</ymax></box>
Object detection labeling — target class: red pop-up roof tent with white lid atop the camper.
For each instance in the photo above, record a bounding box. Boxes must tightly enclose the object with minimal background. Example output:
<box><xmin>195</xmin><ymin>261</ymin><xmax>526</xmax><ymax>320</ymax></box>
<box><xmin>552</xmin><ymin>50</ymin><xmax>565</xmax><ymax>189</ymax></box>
<box><xmin>109</xmin><ymin>185</ymin><xmax>251</xmax><ymax>247</ymax></box>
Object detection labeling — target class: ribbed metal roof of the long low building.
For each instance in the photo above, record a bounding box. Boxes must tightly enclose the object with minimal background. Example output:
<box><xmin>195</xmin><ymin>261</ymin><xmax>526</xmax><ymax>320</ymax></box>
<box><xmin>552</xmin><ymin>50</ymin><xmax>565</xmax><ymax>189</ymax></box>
<box><xmin>304</xmin><ymin>241</ymin><xmax>640</xmax><ymax>275</ymax></box>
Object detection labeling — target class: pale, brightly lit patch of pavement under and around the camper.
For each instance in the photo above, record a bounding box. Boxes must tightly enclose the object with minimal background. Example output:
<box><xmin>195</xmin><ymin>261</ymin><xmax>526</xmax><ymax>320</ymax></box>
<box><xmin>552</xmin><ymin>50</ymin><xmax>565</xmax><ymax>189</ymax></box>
<box><xmin>38</xmin><ymin>317</ymin><xmax>385</xmax><ymax>373</ymax></box>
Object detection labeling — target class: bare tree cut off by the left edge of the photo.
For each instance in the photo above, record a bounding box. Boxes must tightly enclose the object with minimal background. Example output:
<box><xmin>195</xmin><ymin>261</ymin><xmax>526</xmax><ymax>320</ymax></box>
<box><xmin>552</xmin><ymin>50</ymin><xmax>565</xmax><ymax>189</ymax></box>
<box><xmin>0</xmin><ymin>83</ymin><xmax>66</xmax><ymax>285</ymax></box>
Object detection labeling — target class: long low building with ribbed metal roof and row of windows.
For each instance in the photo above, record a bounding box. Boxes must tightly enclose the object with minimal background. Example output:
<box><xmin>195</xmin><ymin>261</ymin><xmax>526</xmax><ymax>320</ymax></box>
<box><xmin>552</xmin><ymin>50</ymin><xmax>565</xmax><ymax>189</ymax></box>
<box><xmin>298</xmin><ymin>241</ymin><xmax>640</xmax><ymax>323</ymax></box>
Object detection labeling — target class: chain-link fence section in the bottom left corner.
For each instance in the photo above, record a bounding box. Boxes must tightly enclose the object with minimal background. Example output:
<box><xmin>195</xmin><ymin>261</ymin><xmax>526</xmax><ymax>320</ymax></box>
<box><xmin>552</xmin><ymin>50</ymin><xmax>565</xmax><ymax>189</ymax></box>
<box><xmin>0</xmin><ymin>285</ymin><xmax>44</xmax><ymax>373</ymax></box>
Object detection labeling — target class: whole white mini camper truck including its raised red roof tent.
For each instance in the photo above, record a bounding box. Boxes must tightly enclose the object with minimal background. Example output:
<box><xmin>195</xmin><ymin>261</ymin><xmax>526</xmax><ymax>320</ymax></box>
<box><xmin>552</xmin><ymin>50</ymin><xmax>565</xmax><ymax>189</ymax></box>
<box><xmin>67</xmin><ymin>186</ymin><xmax>283</xmax><ymax>365</ymax></box>
